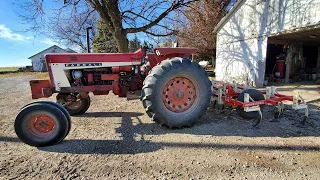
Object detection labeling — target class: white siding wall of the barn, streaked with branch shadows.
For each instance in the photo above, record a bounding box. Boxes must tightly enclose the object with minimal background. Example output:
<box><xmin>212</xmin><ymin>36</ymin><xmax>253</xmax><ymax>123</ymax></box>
<box><xmin>216</xmin><ymin>0</ymin><xmax>320</xmax><ymax>87</ymax></box>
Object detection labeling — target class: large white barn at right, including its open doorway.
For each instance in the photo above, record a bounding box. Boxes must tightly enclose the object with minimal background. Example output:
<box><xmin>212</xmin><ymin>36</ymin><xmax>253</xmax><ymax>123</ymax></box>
<box><xmin>214</xmin><ymin>0</ymin><xmax>320</xmax><ymax>87</ymax></box>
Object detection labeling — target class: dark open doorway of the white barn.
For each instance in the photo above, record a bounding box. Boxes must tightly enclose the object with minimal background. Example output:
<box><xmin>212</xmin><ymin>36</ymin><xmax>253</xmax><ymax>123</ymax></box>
<box><xmin>265</xmin><ymin>27</ymin><xmax>320</xmax><ymax>83</ymax></box>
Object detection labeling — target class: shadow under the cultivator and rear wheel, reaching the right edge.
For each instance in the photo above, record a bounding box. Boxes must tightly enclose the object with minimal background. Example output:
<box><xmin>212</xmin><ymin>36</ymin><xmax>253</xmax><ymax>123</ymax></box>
<box><xmin>131</xmin><ymin>104</ymin><xmax>320</xmax><ymax>138</ymax></box>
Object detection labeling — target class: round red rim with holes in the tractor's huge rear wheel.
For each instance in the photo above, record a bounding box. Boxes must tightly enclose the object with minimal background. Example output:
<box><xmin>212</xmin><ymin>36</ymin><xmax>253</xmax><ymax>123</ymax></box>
<box><xmin>162</xmin><ymin>77</ymin><xmax>197</xmax><ymax>112</ymax></box>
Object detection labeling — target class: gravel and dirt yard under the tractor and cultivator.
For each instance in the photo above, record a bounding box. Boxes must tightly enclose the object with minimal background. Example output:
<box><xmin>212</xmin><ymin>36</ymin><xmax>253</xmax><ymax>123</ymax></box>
<box><xmin>0</xmin><ymin>76</ymin><xmax>320</xmax><ymax>179</ymax></box>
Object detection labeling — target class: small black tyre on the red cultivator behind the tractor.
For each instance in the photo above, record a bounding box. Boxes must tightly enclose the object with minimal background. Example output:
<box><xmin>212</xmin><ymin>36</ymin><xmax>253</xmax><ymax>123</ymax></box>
<box><xmin>237</xmin><ymin>89</ymin><xmax>265</xmax><ymax>120</ymax></box>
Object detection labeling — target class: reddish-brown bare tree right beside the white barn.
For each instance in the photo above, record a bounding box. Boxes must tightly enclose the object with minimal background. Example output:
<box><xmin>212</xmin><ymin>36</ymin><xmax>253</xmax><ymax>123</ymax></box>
<box><xmin>176</xmin><ymin>0</ymin><xmax>233</xmax><ymax>59</ymax></box>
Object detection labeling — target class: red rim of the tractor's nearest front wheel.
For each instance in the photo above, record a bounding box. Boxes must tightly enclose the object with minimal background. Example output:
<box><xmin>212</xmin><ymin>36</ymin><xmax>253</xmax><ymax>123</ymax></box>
<box><xmin>28</xmin><ymin>114</ymin><xmax>55</xmax><ymax>136</ymax></box>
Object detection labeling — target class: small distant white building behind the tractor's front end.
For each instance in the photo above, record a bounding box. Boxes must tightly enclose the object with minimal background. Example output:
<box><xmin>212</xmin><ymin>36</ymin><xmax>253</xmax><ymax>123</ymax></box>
<box><xmin>28</xmin><ymin>45</ymin><xmax>76</xmax><ymax>72</ymax></box>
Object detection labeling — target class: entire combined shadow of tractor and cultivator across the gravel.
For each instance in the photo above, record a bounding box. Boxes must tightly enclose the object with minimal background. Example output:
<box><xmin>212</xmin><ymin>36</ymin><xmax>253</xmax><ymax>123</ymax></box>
<box><xmin>35</xmin><ymin>102</ymin><xmax>320</xmax><ymax>154</ymax></box>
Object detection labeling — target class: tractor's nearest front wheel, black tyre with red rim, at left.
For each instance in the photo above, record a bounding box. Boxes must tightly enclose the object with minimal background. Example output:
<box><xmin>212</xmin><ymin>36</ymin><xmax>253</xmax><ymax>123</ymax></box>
<box><xmin>14</xmin><ymin>102</ymin><xmax>71</xmax><ymax>147</ymax></box>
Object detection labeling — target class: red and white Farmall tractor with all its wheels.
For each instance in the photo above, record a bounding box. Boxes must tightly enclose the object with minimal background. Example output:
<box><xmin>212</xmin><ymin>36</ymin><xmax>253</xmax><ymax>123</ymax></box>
<box><xmin>15</xmin><ymin>48</ymin><xmax>212</xmax><ymax>146</ymax></box>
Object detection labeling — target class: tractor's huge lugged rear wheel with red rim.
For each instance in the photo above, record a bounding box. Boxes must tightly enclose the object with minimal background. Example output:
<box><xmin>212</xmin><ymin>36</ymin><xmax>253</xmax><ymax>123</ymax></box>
<box><xmin>142</xmin><ymin>58</ymin><xmax>212</xmax><ymax>128</ymax></box>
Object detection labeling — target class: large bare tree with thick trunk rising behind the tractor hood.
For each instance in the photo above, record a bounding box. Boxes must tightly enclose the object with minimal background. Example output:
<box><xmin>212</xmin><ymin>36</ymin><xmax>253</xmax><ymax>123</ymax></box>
<box><xmin>16</xmin><ymin>0</ymin><xmax>198</xmax><ymax>52</ymax></box>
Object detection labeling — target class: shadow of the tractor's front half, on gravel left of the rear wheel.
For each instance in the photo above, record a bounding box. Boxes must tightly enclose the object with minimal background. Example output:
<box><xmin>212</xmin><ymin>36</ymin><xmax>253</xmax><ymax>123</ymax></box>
<box><xmin>39</xmin><ymin>112</ymin><xmax>161</xmax><ymax>154</ymax></box>
